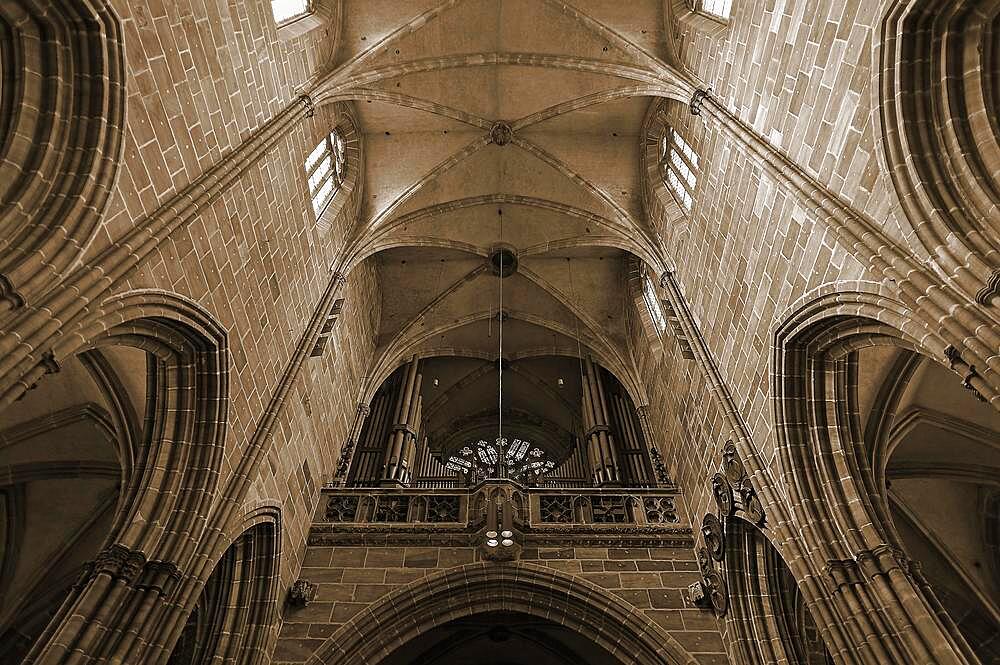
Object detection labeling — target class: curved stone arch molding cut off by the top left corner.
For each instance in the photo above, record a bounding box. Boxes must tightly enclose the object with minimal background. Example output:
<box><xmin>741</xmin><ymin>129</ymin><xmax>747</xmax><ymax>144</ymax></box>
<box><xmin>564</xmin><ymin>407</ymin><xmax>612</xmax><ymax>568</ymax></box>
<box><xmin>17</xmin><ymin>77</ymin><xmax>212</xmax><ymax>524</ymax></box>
<box><xmin>0</xmin><ymin>0</ymin><xmax>125</xmax><ymax>314</ymax></box>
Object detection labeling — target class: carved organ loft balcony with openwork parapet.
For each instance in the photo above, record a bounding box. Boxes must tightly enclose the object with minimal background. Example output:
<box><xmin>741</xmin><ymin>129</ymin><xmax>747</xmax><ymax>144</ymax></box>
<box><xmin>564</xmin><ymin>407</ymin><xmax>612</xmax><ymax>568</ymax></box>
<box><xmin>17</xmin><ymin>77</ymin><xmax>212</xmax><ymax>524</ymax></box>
<box><xmin>309</xmin><ymin>479</ymin><xmax>692</xmax><ymax>560</ymax></box>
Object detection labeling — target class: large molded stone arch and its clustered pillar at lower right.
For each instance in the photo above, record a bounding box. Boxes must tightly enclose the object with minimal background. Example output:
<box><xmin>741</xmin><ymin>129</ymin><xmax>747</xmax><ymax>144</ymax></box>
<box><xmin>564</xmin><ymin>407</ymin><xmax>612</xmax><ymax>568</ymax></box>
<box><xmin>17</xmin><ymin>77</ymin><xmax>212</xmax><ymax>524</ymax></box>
<box><xmin>772</xmin><ymin>284</ymin><xmax>975</xmax><ymax>663</ymax></box>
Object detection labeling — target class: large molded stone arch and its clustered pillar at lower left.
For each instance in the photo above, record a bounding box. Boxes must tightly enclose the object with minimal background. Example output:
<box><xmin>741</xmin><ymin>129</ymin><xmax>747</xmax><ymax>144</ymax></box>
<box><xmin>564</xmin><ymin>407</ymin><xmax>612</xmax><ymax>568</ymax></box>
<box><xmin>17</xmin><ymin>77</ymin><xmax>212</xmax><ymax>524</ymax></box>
<box><xmin>26</xmin><ymin>290</ymin><xmax>228</xmax><ymax>663</ymax></box>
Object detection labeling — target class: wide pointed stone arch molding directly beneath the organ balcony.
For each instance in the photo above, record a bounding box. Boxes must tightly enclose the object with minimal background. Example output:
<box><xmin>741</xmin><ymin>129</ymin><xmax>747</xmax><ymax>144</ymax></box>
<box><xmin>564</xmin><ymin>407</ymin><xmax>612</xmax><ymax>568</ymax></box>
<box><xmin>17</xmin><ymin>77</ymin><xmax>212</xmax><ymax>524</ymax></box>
<box><xmin>307</xmin><ymin>563</ymin><xmax>697</xmax><ymax>665</ymax></box>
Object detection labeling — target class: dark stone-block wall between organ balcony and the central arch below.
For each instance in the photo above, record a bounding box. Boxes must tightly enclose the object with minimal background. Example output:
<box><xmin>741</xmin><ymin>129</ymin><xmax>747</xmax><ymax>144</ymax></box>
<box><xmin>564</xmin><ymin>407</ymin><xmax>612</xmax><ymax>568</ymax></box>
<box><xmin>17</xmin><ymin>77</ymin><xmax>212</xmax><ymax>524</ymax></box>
<box><xmin>274</xmin><ymin>546</ymin><xmax>728</xmax><ymax>664</ymax></box>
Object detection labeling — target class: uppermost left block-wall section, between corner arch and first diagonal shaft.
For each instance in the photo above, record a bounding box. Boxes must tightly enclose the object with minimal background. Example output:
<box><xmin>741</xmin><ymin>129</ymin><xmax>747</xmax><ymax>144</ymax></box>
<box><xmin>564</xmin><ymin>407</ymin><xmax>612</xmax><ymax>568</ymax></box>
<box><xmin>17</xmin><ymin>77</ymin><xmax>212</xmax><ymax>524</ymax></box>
<box><xmin>88</xmin><ymin>0</ymin><xmax>336</xmax><ymax>256</ymax></box>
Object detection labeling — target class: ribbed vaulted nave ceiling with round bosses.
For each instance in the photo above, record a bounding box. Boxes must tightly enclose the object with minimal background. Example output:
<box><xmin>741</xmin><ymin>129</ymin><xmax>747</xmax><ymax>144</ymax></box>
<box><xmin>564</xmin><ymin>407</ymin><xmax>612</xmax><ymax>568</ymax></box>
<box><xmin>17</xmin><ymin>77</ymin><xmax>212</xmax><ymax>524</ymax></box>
<box><xmin>323</xmin><ymin>0</ymin><xmax>696</xmax><ymax>394</ymax></box>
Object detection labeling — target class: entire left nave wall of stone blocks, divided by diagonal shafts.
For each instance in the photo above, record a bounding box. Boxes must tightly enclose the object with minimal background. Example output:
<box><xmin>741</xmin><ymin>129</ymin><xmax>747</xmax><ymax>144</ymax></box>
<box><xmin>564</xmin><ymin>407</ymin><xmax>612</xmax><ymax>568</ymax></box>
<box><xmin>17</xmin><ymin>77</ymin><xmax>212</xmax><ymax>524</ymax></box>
<box><xmin>80</xmin><ymin>0</ymin><xmax>381</xmax><ymax>588</ymax></box>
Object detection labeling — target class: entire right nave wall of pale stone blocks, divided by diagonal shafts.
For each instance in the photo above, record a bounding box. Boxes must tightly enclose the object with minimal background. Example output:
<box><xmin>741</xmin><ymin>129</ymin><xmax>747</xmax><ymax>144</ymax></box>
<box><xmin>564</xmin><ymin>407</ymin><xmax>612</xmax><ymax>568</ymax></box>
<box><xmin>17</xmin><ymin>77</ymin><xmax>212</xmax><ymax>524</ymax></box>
<box><xmin>631</xmin><ymin>0</ymin><xmax>928</xmax><ymax>519</ymax></box>
